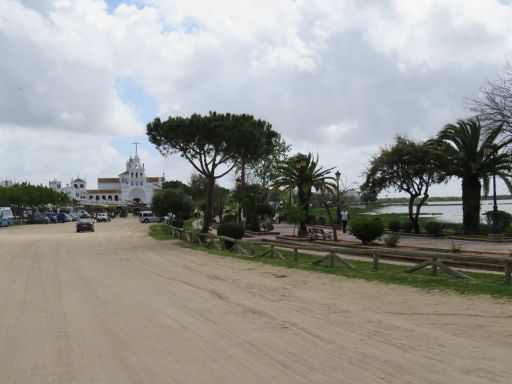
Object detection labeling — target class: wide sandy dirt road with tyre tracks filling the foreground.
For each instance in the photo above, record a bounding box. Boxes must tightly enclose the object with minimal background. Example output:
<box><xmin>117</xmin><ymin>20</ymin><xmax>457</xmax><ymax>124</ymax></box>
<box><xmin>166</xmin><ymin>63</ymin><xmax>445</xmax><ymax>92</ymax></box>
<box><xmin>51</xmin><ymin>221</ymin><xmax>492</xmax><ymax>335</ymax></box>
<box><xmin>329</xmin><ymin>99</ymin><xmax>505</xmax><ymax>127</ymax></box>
<box><xmin>0</xmin><ymin>219</ymin><xmax>512</xmax><ymax>384</ymax></box>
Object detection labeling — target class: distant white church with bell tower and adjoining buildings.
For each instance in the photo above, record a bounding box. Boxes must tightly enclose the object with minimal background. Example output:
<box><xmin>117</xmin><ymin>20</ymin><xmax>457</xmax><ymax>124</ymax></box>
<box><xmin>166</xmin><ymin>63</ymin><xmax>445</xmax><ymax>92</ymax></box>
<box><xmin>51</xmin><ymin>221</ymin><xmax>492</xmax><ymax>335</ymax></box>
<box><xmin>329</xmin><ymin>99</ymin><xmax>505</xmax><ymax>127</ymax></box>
<box><xmin>49</xmin><ymin>143</ymin><xmax>165</xmax><ymax>205</ymax></box>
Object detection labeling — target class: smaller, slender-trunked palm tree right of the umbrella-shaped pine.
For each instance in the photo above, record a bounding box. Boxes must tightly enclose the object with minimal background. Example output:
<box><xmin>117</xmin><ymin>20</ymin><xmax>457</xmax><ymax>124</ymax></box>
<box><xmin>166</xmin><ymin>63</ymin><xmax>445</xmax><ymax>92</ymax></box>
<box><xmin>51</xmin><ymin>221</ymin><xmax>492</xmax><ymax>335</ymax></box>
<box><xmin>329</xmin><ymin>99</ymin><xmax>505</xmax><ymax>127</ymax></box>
<box><xmin>273</xmin><ymin>153</ymin><xmax>336</xmax><ymax>236</ymax></box>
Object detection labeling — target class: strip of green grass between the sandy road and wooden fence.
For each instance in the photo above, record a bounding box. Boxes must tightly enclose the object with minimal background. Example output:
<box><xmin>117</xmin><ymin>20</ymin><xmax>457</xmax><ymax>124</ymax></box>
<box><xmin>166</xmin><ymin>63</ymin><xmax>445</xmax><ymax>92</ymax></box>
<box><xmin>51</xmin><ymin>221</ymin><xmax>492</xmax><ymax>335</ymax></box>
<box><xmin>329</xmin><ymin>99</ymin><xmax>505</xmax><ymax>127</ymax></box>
<box><xmin>149</xmin><ymin>224</ymin><xmax>512</xmax><ymax>299</ymax></box>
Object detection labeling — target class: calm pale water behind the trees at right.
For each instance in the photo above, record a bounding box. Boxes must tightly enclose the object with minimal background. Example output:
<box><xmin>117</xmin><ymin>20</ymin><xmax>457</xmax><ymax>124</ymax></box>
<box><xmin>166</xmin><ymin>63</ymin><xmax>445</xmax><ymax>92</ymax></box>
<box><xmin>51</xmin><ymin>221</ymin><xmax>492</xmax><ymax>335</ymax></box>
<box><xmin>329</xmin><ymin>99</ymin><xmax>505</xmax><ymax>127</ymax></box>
<box><xmin>375</xmin><ymin>200</ymin><xmax>512</xmax><ymax>223</ymax></box>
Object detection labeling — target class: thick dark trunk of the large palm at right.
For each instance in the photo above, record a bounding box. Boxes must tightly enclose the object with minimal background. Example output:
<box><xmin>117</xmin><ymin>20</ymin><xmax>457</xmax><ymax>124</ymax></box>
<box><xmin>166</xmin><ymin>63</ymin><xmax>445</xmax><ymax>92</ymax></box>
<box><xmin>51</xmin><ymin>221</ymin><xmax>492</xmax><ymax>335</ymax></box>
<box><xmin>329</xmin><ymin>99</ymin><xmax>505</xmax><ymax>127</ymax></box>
<box><xmin>462</xmin><ymin>176</ymin><xmax>481</xmax><ymax>235</ymax></box>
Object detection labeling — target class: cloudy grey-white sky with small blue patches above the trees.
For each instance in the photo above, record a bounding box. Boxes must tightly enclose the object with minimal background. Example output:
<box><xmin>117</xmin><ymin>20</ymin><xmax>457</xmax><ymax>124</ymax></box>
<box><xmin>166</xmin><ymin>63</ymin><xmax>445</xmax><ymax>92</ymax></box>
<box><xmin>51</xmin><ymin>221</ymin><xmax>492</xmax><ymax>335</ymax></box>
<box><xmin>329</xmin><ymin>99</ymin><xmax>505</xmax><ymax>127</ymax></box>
<box><xmin>0</xmin><ymin>0</ymin><xmax>512</xmax><ymax>195</ymax></box>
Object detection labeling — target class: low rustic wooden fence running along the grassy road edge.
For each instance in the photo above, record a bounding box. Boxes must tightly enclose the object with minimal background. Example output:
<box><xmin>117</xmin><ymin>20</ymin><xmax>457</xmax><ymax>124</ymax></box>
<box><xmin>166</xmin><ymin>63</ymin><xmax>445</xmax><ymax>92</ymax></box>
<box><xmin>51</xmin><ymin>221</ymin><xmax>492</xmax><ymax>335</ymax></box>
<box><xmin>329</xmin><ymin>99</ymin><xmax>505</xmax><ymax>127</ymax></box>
<box><xmin>164</xmin><ymin>224</ymin><xmax>512</xmax><ymax>284</ymax></box>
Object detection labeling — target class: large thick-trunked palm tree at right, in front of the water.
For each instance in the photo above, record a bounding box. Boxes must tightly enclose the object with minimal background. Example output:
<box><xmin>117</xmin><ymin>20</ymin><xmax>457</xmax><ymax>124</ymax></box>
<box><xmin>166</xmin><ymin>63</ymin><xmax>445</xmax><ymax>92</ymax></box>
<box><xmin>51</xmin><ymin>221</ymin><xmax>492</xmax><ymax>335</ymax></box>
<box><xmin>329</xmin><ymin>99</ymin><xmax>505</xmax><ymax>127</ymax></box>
<box><xmin>437</xmin><ymin>118</ymin><xmax>512</xmax><ymax>234</ymax></box>
